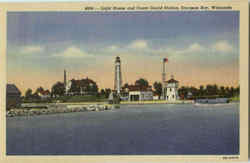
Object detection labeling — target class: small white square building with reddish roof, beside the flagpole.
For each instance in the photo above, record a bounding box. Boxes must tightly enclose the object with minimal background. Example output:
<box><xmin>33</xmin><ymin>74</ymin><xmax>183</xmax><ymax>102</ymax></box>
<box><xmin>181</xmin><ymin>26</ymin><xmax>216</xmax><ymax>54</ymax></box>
<box><xmin>165</xmin><ymin>76</ymin><xmax>179</xmax><ymax>101</ymax></box>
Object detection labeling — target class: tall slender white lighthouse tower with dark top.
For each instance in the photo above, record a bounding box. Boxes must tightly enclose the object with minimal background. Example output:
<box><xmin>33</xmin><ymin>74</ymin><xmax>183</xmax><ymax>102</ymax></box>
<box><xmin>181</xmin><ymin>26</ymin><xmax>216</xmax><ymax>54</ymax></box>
<box><xmin>115</xmin><ymin>56</ymin><xmax>122</xmax><ymax>95</ymax></box>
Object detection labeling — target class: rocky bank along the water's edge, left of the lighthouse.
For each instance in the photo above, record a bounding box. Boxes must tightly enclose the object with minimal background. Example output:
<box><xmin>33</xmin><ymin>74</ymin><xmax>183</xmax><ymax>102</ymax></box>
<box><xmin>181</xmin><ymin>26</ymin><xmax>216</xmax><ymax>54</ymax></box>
<box><xmin>6</xmin><ymin>105</ymin><xmax>120</xmax><ymax>117</ymax></box>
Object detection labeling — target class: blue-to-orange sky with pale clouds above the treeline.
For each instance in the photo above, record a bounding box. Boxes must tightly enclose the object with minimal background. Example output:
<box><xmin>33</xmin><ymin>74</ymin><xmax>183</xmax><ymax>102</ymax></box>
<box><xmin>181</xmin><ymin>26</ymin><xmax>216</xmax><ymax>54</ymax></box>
<box><xmin>7</xmin><ymin>11</ymin><xmax>239</xmax><ymax>93</ymax></box>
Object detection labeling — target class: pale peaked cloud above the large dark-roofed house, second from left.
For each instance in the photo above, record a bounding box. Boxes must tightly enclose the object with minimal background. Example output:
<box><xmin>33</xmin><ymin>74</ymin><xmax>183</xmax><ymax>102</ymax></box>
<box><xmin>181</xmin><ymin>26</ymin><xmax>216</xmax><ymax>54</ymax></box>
<box><xmin>52</xmin><ymin>46</ymin><xmax>93</xmax><ymax>58</ymax></box>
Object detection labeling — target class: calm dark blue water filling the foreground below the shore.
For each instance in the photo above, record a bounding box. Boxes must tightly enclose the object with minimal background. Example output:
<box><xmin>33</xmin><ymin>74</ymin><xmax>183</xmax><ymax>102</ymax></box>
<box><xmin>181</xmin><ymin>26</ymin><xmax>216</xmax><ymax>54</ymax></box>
<box><xmin>7</xmin><ymin>104</ymin><xmax>239</xmax><ymax>155</ymax></box>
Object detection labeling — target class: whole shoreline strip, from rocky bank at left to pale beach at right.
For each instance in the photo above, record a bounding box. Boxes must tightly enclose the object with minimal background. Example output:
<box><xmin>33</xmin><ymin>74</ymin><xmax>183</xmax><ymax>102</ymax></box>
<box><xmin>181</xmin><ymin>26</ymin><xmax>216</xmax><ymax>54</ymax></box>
<box><xmin>6</xmin><ymin>100</ymin><xmax>237</xmax><ymax>117</ymax></box>
